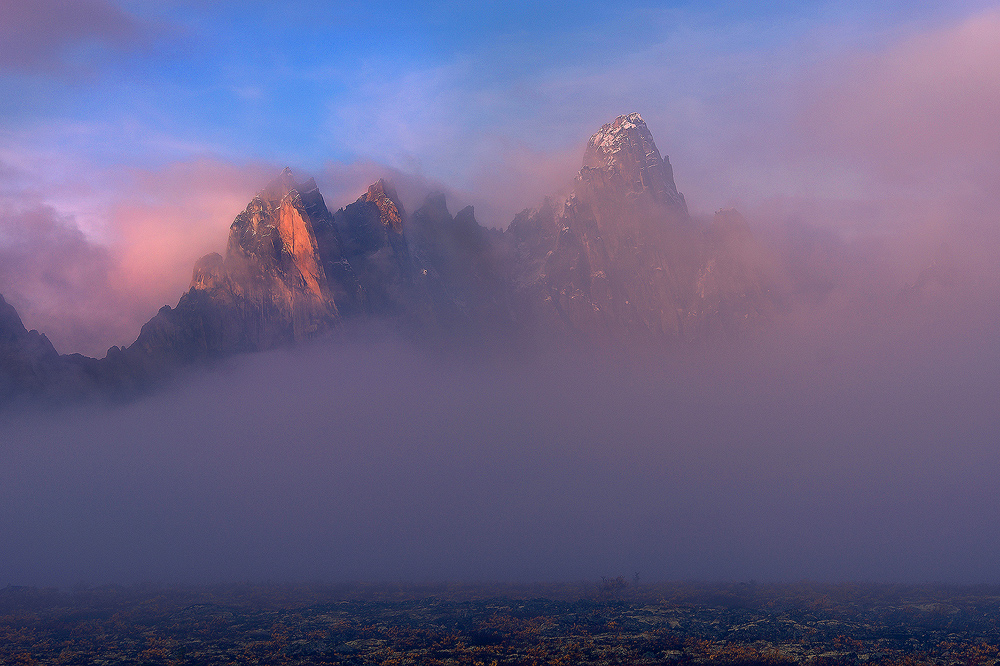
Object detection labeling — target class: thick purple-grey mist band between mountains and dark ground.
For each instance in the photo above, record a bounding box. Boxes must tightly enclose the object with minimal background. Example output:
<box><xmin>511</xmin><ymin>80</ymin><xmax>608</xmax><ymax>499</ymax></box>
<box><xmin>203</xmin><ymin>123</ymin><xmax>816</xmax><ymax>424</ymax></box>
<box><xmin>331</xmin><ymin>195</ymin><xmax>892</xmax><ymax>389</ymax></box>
<box><xmin>0</xmin><ymin>272</ymin><xmax>1000</xmax><ymax>586</ymax></box>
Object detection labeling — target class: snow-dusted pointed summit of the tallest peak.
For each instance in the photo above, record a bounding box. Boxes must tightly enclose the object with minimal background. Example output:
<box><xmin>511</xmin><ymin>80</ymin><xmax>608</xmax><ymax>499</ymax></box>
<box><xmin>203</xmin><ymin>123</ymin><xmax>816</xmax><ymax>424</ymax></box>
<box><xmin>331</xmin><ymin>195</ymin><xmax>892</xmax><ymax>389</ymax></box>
<box><xmin>583</xmin><ymin>113</ymin><xmax>687</xmax><ymax>215</ymax></box>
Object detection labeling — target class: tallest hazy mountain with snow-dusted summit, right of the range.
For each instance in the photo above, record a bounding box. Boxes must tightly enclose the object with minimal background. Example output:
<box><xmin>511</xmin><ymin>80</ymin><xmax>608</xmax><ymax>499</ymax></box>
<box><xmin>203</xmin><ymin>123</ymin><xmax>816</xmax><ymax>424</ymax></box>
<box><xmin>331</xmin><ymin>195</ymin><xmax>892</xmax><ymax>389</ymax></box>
<box><xmin>504</xmin><ymin>113</ymin><xmax>772</xmax><ymax>342</ymax></box>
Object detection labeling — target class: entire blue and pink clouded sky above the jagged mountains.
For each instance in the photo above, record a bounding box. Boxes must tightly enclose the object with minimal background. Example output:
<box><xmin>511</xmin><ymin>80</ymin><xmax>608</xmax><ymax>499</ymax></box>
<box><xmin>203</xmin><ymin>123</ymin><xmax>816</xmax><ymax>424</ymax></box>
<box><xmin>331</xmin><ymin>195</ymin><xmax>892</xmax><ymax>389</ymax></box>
<box><xmin>0</xmin><ymin>0</ymin><xmax>997</xmax><ymax>354</ymax></box>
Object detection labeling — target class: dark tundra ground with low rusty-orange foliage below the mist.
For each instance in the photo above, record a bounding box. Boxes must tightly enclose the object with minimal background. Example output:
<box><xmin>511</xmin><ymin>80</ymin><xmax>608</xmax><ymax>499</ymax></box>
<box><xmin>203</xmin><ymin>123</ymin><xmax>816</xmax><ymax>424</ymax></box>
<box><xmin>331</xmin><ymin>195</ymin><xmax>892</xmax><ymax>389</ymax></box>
<box><xmin>0</xmin><ymin>577</ymin><xmax>1000</xmax><ymax>666</ymax></box>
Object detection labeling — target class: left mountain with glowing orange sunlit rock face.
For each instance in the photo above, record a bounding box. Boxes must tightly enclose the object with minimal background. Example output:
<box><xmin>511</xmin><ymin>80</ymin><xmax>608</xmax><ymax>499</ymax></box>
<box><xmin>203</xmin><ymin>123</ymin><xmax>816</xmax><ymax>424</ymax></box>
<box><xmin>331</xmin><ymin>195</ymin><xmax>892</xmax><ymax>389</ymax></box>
<box><xmin>129</xmin><ymin>169</ymin><xmax>362</xmax><ymax>364</ymax></box>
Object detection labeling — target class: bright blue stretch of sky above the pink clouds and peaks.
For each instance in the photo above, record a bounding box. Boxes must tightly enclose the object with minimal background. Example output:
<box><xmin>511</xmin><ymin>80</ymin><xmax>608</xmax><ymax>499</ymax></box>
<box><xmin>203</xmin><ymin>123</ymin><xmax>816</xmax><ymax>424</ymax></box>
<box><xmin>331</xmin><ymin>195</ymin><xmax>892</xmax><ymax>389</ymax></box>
<box><xmin>0</xmin><ymin>0</ymin><xmax>984</xmax><ymax>179</ymax></box>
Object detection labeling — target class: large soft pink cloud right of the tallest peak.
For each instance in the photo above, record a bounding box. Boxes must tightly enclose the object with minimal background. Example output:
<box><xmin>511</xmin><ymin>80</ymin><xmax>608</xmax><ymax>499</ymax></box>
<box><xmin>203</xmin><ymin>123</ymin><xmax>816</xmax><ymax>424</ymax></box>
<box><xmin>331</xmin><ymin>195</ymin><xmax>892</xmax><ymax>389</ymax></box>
<box><xmin>737</xmin><ymin>10</ymin><xmax>1000</xmax><ymax>282</ymax></box>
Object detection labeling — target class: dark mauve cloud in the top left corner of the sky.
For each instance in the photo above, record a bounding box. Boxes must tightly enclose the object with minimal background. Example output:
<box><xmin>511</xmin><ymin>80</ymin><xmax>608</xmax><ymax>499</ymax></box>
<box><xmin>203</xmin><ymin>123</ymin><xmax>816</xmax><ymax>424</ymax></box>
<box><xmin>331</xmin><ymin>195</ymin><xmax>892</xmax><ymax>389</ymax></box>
<box><xmin>0</xmin><ymin>0</ymin><xmax>153</xmax><ymax>74</ymax></box>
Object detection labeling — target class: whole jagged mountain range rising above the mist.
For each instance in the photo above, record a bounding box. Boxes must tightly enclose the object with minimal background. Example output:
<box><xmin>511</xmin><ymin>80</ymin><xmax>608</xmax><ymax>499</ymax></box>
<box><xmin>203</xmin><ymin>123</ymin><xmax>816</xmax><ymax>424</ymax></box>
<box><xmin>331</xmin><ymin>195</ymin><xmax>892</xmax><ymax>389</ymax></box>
<box><xmin>0</xmin><ymin>113</ymin><xmax>777</xmax><ymax>401</ymax></box>
